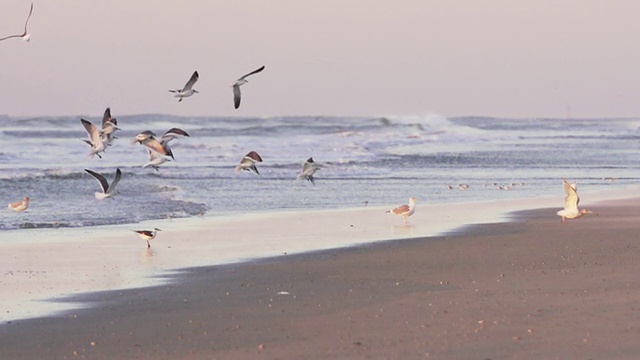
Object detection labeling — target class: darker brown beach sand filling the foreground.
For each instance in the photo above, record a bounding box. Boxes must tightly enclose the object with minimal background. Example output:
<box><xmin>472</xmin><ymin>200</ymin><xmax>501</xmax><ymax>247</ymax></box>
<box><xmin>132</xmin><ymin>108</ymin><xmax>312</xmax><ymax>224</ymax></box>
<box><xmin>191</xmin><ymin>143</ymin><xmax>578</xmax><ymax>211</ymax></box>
<box><xmin>0</xmin><ymin>199</ymin><xmax>640</xmax><ymax>359</ymax></box>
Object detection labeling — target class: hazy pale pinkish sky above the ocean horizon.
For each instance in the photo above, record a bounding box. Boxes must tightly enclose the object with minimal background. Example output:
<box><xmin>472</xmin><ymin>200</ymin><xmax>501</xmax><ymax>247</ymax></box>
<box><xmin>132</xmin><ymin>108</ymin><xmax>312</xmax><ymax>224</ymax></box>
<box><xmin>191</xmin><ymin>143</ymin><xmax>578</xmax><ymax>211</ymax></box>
<box><xmin>0</xmin><ymin>0</ymin><xmax>640</xmax><ymax>117</ymax></box>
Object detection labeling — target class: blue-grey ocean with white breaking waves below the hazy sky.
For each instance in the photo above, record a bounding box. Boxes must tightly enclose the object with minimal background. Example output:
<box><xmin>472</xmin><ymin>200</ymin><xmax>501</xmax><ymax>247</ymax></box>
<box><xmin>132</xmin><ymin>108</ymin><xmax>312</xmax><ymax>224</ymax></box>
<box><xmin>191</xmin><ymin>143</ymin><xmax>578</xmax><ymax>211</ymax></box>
<box><xmin>0</xmin><ymin>114</ymin><xmax>640</xmax><ymax>232</ymax></box>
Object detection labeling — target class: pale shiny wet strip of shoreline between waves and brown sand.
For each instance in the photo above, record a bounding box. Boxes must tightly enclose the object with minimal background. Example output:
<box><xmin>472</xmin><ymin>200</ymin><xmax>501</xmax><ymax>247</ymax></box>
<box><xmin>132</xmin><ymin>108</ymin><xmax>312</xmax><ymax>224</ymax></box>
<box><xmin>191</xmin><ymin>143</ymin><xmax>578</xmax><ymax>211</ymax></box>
<box><xmin>0</xmin><ymin>188</ymin><xmax>640</xmax><ymax>323</ymax></box>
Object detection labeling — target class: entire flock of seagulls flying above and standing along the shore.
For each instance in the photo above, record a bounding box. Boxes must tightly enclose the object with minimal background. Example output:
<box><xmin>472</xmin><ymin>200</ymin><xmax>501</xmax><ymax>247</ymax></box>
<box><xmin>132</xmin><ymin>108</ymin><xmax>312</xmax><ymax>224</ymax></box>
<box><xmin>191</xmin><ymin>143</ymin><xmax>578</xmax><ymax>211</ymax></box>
<box><xmin>0</xmin><ymin>3</ymin><xmax>597</xmax><ymax>248</ymax></box>
